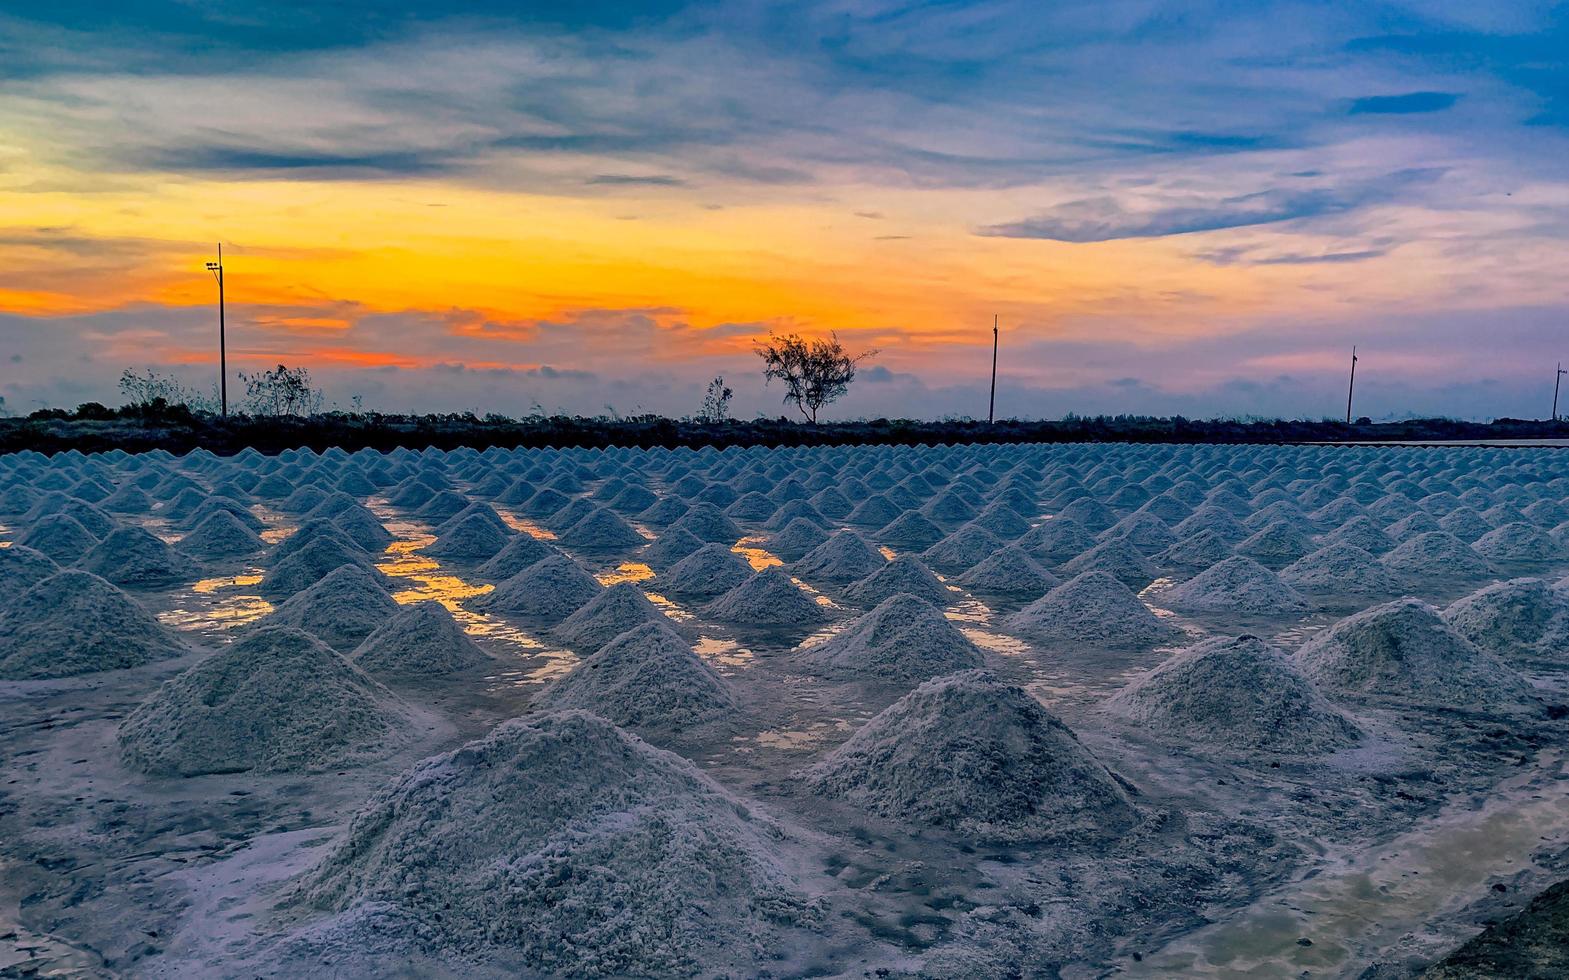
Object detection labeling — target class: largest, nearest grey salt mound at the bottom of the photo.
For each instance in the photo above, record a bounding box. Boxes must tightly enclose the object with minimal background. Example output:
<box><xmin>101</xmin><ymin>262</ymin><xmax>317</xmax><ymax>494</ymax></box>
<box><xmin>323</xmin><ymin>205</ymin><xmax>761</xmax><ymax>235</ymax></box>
<box><xmin>295</xmin><ymin>712</ymin><xmax>821</xmax><ymax>977</ymax></box>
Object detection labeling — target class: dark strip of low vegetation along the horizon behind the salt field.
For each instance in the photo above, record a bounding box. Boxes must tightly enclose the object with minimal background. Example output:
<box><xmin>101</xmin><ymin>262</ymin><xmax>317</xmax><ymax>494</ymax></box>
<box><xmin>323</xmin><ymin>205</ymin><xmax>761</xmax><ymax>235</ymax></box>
<box><xmin>0</xmin><ymin>406</ymin><xmax>1569</xmax><ymax>455</ymax></box>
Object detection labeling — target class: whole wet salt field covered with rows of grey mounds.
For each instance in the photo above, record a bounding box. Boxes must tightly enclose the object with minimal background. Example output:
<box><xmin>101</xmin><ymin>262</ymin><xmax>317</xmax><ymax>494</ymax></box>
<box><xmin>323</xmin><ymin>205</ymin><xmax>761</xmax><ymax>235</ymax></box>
<box><xmin>0</xmin><ymin>445</ymin><xmax>1569</xmax><ymax>977</ymax></box>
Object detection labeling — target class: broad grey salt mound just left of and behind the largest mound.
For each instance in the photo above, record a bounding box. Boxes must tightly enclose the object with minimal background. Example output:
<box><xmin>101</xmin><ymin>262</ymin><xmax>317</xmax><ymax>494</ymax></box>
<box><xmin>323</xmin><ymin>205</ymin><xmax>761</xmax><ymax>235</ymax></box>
<box><xmin>119</xmin><ymin>629</ymin><xmax>411</xmax><ymax>776</ymax></box>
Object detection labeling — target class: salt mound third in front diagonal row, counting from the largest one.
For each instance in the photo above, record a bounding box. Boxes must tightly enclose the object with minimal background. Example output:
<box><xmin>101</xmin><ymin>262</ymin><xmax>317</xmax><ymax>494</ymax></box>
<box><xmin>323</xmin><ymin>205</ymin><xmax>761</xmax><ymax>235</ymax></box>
<box><xmin>1106</xmin><ymin>635</ymin><xmax>1362</xmax><ymax>754</ymax></box>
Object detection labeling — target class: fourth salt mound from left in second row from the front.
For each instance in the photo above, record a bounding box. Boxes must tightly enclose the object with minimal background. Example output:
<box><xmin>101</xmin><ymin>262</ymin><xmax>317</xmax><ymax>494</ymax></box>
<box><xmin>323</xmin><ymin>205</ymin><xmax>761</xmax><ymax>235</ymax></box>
<box><xmin>1006</xmin><ymin>572</ymin><xmax>1180</xmax><ymax>648</ymax></box>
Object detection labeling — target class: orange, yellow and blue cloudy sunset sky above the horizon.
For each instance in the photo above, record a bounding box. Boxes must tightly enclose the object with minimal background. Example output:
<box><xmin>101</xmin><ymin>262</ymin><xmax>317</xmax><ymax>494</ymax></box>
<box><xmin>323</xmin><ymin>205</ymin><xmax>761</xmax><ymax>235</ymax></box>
<box><xmin>0</xmin><ymin>0</ymin><xmax>1569</xmax><ymax>417</ymax></box>
